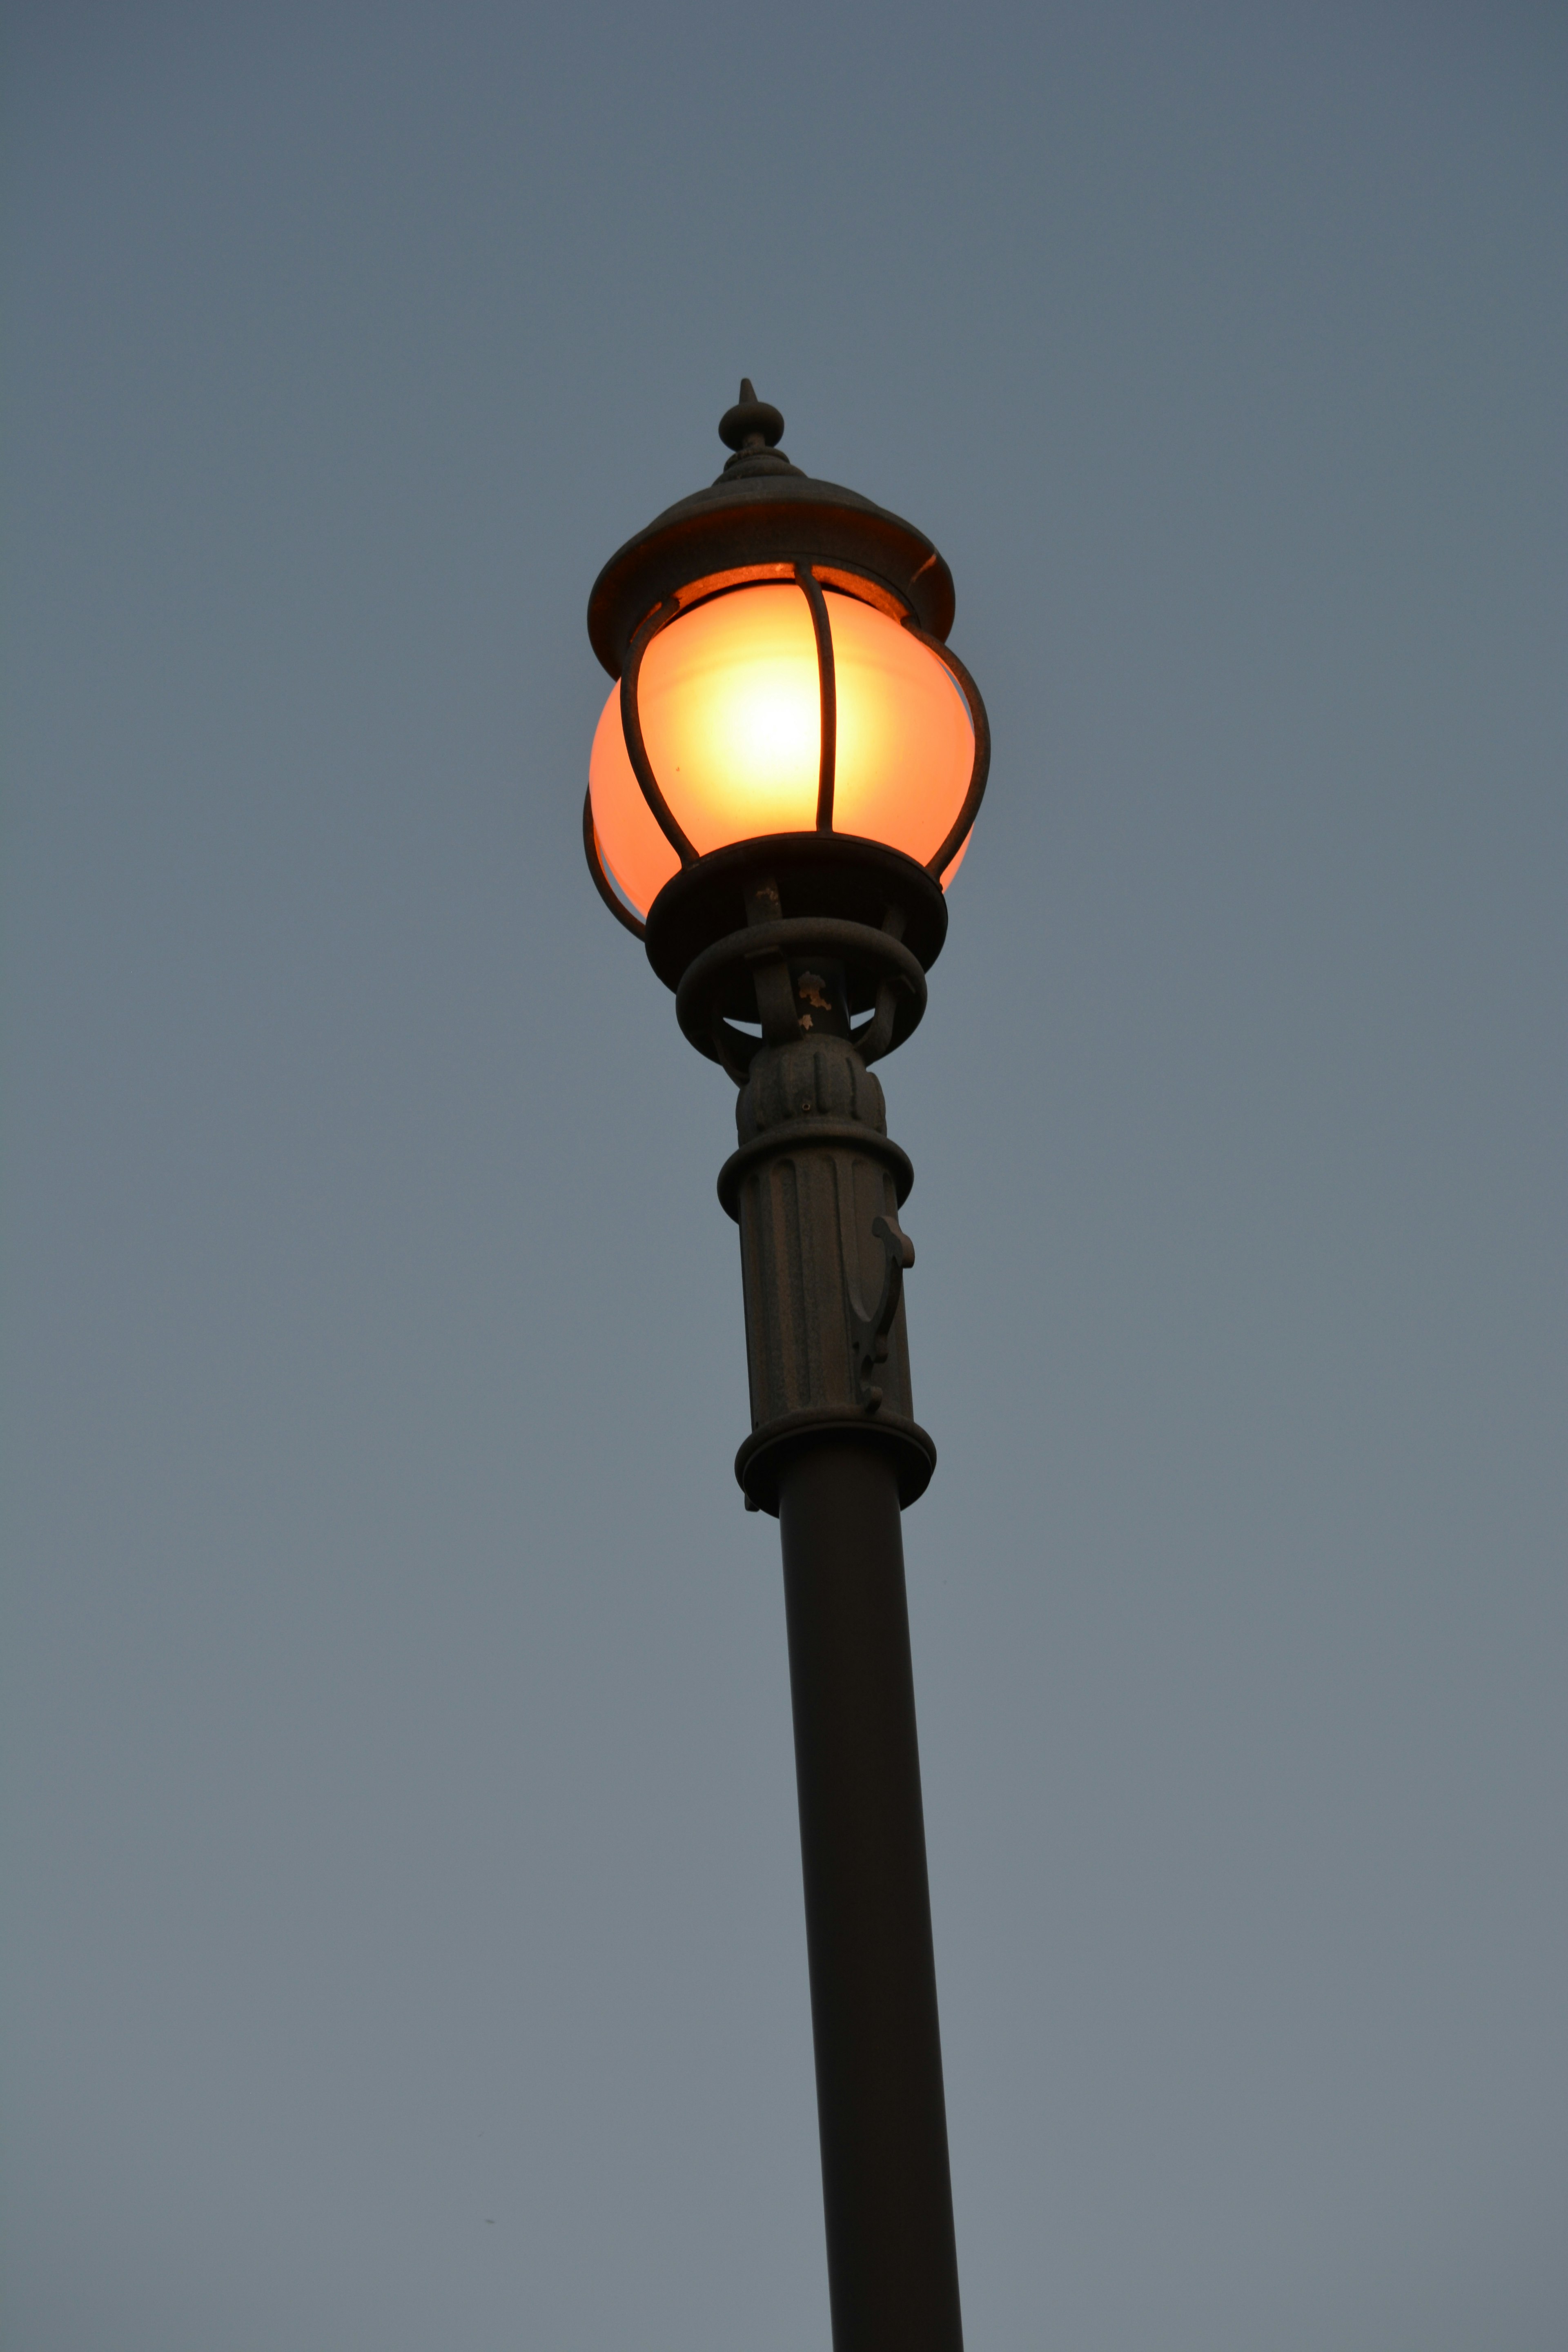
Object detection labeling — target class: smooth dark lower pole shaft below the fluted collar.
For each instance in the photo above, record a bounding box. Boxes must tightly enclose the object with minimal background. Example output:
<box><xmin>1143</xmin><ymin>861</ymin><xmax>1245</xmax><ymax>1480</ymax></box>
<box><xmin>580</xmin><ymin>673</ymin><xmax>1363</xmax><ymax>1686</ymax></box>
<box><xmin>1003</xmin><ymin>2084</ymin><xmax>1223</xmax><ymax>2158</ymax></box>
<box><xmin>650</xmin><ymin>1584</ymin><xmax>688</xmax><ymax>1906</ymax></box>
<box><xmin>778</xmin><ymin>1439</ymin><xmax>964</xmax><ymax>2352</ymax></box>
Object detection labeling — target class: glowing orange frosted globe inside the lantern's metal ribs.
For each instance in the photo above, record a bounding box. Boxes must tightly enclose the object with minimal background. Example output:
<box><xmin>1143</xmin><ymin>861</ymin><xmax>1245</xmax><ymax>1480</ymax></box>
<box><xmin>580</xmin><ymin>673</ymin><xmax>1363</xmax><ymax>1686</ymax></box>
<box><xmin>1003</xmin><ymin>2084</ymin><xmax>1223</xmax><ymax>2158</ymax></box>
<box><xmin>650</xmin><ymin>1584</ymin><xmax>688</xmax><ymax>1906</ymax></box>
<box><xmin>588</xmin><ymin>583</ymin><xmax>976</xmax><ymax>915</ymax></box>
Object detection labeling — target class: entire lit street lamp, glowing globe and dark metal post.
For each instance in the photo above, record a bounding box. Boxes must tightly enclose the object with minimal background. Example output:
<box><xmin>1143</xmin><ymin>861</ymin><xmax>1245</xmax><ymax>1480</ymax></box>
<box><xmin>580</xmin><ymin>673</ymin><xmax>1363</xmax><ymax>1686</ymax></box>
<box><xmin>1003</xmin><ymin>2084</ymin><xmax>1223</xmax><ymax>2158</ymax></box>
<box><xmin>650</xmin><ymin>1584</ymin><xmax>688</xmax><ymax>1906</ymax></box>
<box><xmin>583</xmin><ymin>383</ymin><xmax>990</xmax><ymax>2352</ymax></box>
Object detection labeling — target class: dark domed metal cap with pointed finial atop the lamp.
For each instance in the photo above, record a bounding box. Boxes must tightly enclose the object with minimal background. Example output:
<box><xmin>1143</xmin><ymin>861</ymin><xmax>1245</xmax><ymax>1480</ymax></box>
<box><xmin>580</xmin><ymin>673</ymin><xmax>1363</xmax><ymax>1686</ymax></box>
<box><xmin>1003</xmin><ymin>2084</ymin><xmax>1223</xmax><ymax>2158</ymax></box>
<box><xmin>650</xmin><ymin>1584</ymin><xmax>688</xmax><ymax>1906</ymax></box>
<box><xmin>588</xmin><ymin>376</ymin><xmax>954</xmax><ymax>677</ymax></box>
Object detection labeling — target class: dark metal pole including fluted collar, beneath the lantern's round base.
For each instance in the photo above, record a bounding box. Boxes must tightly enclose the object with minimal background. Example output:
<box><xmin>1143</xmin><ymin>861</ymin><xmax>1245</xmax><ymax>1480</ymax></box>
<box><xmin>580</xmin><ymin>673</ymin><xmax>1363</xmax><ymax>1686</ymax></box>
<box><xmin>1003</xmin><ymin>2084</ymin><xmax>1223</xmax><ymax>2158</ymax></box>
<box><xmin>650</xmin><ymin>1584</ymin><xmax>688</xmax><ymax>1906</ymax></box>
<box><xmin>719</xmin><ymin>927</ymin><xmax>964</xmax><ymax>2352</ymax></box>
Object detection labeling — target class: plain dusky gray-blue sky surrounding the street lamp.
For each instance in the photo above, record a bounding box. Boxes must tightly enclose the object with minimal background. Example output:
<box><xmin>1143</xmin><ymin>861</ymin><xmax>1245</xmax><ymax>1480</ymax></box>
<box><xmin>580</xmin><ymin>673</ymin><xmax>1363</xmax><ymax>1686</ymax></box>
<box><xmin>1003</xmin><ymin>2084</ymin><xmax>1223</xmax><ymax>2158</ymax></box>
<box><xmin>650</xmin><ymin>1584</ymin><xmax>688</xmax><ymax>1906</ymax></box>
<box><xmin>2</xmin><ymin>0</ymin><xmax>1568</xmax><ymax>2352</ymax></box>
